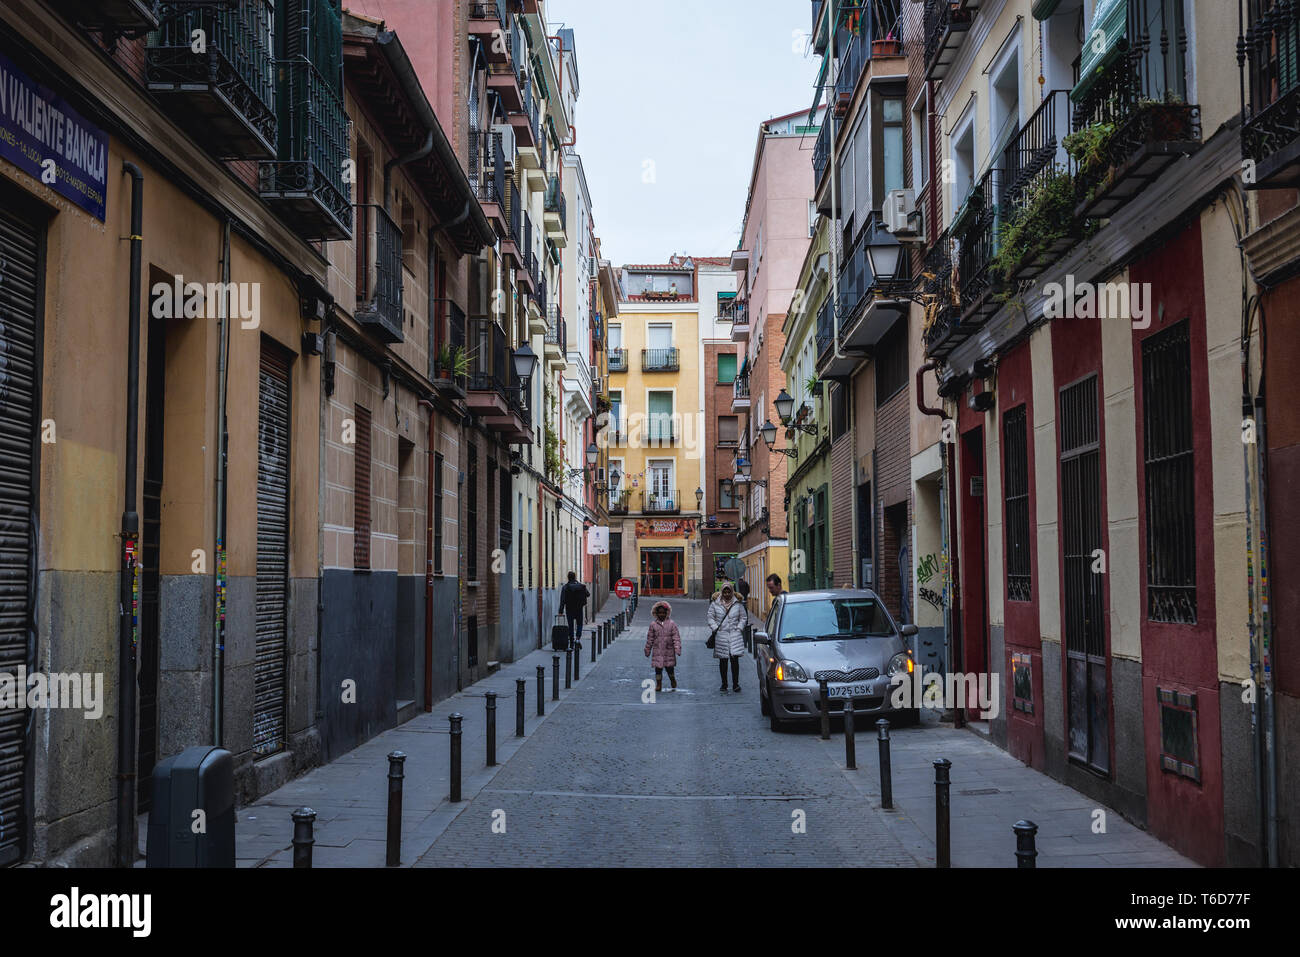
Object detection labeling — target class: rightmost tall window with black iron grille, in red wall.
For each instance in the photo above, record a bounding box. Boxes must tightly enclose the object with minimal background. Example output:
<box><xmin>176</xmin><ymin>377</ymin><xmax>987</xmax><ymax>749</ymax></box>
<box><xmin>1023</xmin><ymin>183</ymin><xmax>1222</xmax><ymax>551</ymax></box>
<box><xmin>1141</xmin><ymin>320</ymin><xmax>1196</xmax><ymax>624</ymax></box>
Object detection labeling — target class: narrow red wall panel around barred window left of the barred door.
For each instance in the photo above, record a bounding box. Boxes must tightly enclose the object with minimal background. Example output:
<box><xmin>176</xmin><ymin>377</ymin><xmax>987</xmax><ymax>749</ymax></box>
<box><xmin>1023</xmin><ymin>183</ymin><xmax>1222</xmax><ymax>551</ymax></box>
<box><xmin>997</xmin><ymin>341</ymin><xmax>1044</xmax><ymax>770</ymax></box>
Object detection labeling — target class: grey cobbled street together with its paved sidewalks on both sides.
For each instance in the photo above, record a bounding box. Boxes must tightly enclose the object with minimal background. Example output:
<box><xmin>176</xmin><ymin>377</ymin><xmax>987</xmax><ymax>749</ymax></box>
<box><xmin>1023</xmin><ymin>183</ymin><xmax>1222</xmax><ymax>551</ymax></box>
<box><xmin>238</xmin><ymin>599</ymin><xmax>1191</xmax><ymax>867</ymax></box>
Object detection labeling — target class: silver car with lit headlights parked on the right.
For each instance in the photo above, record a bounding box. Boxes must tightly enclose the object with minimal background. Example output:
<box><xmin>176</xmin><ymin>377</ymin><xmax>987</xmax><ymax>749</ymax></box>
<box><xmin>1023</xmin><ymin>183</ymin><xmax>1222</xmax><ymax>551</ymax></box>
<box><xmin>754</xmin><ymin>589</ymin><xmax>918</xmax><ymax>731</ymax></box>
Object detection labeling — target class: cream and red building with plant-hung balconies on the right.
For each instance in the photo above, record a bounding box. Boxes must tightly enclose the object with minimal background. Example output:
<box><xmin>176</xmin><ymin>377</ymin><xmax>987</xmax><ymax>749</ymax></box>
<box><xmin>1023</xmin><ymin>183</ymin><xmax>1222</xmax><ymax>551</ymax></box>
<box><xmin>905</xmin><ymin>0</ymin><xmax>1295</xmax><ymax>865</ymax></box>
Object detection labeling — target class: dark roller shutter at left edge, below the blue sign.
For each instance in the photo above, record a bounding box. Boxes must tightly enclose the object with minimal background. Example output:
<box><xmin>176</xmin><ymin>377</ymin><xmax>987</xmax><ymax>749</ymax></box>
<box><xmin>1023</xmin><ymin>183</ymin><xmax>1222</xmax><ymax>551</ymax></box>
<box><xmin>0</xmin><ymin>209</ymin><xmax>40</xmax><ymax>867</ymax></box>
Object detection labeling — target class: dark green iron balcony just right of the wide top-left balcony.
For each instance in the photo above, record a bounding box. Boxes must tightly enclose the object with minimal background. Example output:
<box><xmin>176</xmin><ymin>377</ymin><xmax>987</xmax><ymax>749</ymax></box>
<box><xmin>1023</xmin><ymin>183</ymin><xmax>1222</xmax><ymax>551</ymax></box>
<box><xmin>257</xmin><ymin>60</ymin><xmax>352</xmax><ymax>239</ymax></box>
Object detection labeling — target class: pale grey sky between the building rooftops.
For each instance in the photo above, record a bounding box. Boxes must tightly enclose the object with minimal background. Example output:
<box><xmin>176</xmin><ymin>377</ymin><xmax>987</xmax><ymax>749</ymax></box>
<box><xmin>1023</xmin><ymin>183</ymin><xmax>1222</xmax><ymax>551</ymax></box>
<box><xmin>546</xmin><ymin>0</ymin><xmax>818</xmax><ymax>263</ymax></box>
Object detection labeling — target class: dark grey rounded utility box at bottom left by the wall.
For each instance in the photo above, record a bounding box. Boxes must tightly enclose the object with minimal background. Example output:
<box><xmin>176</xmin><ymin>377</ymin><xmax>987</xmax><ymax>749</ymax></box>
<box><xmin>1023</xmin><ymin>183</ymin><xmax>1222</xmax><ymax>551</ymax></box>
<box><xmin>146</xmin><ymin>745</ymin><xmax>235</xmax><ymax>867</ymax></box>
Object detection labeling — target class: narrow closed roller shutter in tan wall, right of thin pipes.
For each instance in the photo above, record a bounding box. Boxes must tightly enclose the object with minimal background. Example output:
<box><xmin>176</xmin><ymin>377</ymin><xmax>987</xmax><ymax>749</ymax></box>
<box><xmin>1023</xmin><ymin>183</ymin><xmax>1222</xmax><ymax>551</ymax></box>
<box><xmin>252</xmin><ymin>341</ymin><xmax>289</xmax><ymax>754</ymax></box>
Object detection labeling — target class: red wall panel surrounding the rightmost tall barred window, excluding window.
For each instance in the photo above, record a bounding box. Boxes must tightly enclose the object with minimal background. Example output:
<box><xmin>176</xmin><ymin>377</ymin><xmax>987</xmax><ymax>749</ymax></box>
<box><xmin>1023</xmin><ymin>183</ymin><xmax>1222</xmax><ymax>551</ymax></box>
<box><xmin>1130</xmin><ymin>224</ymin><xmax>1216</xmax><ymax>866</ymax></box>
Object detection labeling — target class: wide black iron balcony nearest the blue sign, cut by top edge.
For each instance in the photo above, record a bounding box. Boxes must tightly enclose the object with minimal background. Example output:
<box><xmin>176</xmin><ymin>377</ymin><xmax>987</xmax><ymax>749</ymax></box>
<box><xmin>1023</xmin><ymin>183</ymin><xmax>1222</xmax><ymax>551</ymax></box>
<box><xmin>144</xmin><ymin>0</ymin><xmax>276</xmax><ymax>160</ymax></box>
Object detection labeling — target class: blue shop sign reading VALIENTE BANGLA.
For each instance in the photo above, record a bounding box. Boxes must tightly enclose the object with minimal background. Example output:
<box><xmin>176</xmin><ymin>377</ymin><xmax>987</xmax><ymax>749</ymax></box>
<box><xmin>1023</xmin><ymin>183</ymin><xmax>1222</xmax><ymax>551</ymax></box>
<box><xmin>0</xmin><ymin>53</ymin><xmax>108</xmax><ymax>222</ymax></box>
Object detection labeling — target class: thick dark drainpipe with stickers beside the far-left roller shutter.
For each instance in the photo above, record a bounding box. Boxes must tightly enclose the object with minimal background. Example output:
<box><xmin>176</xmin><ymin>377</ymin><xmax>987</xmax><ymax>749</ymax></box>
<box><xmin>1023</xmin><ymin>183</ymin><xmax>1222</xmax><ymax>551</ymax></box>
<box><xmin>117</xmin><ymin>163</ymin><xmax>144</xmax><ymax>867</ymax></box>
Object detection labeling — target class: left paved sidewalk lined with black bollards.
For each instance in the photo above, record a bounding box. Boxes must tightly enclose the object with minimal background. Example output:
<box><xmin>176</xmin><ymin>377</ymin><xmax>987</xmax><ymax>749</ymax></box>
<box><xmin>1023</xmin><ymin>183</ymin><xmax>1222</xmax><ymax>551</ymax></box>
<box><xmin>235</xmin><ymin>597</ymin><xmax>644</xmax><ymax>867</ymax></box>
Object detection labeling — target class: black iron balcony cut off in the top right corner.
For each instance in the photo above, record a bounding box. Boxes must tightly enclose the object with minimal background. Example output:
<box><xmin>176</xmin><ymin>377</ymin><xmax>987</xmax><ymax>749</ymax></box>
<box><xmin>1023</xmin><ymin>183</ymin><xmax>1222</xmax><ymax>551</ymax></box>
<box><xmin>1238</xmin><ymin>0</ymin><xmax>1300</xmax><ymax>190</ymax></box>
